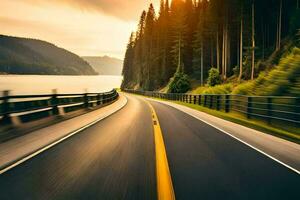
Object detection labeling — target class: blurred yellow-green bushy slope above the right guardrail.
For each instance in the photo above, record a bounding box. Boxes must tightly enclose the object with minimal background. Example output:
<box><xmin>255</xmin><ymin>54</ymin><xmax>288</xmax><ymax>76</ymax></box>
<box><xmin>190</xmin><ymin>47</ymin><xmax>300</xmax><ymax>97</ymax></box>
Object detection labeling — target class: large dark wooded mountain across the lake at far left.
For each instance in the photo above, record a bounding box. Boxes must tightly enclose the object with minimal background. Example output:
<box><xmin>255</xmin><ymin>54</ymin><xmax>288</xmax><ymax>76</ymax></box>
<box><xmin>0</xmin><ymin>35</ymin><xmax>97</xmax><ymax>75</ymax></box>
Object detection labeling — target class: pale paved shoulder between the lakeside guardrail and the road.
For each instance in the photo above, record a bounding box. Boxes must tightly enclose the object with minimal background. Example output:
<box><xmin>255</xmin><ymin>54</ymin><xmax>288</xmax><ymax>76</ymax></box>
<box><xmin>0</xmin><ymin>95</ymin><xmax>127</xmax><ymax>174</ymax></box>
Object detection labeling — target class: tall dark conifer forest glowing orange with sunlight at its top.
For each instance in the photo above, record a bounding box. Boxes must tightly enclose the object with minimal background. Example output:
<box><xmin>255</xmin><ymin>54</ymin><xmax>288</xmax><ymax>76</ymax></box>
<box><xmin>122</xmin><ymin>0</ymin><xmax>300</xmax><ymax>92</ymax></box>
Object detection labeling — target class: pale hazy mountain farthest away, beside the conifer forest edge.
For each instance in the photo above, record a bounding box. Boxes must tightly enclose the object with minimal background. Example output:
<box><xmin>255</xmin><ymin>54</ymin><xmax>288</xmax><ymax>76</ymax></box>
<box><xmin>82</xmin><ymin>56</ymin><xmax>123</xmax><ymax>75</ymax></box>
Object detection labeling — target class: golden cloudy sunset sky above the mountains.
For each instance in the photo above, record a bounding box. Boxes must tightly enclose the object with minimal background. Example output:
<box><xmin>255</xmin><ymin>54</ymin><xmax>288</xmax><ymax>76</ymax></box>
<box><xmin>0</xmin><ymin>0</ymin><xmax>159</xmax><ymax>59</ymax></box>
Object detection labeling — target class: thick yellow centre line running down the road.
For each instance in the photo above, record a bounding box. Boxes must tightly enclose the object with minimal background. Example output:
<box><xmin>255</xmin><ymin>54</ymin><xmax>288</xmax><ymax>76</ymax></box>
<box><xmin>147</xmin><ymin>102</ymin><xmax>175</xmax><ymax>200</ymax></box>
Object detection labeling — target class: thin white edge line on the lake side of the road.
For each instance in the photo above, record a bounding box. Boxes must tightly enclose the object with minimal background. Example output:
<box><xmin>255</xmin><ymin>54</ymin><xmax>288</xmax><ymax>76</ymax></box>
<box><xmin>0</xmin><ymin>95</ymin><xmax>128</xmax><ymax>175</ymax></box>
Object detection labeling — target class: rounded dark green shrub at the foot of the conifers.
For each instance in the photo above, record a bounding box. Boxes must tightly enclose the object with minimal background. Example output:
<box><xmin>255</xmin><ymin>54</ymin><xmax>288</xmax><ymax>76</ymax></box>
<box><xmin>168</xmin><ymin>72</ymin><xmax>191</xmax><ymax>93</ymax></box>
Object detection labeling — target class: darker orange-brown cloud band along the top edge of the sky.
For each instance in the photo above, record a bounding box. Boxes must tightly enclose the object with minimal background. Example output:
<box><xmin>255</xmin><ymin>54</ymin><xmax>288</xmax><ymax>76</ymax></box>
<box><xmin>20</xmin><ymin>0</ymin><xmax>159</xmax><ymax>21</ymax></box>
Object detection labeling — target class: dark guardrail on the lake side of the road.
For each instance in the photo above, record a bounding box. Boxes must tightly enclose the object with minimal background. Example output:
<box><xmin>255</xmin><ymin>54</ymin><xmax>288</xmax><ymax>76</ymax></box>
<box><xmin>0</xmin><ymin>89</ymin><xmax>119</xmax><ymax>123</ymax></box>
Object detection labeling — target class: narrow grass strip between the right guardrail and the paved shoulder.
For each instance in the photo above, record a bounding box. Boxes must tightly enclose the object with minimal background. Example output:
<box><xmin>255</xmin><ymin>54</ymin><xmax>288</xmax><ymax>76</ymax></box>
<box><xmin>128</xmin><ymin>92</ymin><xmax>300</xmax><ymax>144</ymax></box>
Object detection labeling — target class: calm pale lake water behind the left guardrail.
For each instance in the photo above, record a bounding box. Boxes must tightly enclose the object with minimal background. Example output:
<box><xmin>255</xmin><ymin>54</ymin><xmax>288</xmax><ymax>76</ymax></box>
<box><xmin>0</xmin><ymin>75</ymin><xmax>122</xmax><ymax>96</ymax></box>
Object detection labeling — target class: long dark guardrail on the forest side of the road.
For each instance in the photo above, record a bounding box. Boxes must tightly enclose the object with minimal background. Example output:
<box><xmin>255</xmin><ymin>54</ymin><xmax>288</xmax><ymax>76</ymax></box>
<box><xmin>124</xmin><ymin>90</ymin><xmax>300</xmax><ymax>128</ymax></box>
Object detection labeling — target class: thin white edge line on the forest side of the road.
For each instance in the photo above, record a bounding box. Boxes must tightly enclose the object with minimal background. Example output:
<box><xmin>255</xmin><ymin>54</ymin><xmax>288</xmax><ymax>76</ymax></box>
<box><xmin>150</xmin><ymin>99</ymin><xmax>300</xmax><ymax>175</ymax></box>
